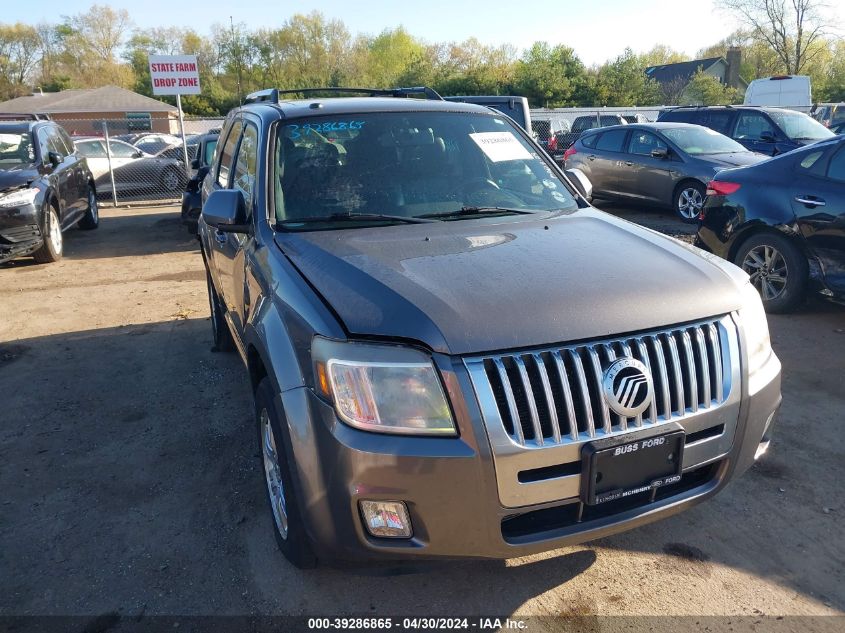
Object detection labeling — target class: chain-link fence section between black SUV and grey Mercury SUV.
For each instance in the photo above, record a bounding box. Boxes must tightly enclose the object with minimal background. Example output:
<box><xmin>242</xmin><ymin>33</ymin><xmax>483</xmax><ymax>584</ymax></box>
<box><xmin>53</xmin><ymin>116</ymin><xmax>223</xmax><ymax>206</ymax></box>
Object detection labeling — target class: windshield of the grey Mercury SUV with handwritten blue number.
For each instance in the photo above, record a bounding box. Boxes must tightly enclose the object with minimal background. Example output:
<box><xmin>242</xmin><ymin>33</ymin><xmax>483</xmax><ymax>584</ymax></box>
<box><xmin>274</xmin><ymin>112</ymin><xmax>578</xmax><ymax>230</ymax></box>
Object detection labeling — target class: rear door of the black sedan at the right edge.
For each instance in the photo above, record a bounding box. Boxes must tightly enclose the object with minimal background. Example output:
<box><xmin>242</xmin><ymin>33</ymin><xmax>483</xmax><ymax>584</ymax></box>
<box><xmin>791</xmin><ymin>141</ymin><xmax>845</xmax><ymax>296</ymax></box>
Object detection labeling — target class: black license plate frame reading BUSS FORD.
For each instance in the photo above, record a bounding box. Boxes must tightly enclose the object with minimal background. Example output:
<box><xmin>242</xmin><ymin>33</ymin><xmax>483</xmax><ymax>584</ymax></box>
<box><xmin>581</xmin><ymin>423</ymin><xmax>686</xmax><ymax>505</ymax></box>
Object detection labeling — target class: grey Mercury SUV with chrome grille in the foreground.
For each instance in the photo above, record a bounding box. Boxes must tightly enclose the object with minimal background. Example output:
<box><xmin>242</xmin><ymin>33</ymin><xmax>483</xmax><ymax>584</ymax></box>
<box><xmin>199</xmin><ymin>88</ymin><xmax>781</xmax><ymax>567</ymax></box>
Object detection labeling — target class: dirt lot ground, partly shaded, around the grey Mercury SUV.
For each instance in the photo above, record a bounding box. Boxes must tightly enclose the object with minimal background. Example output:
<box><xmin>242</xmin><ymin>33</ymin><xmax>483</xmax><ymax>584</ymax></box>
<box><xmin>0</xmin><ymin>207</ymin><xmax>845</xmax><ymax>622</ymax></box>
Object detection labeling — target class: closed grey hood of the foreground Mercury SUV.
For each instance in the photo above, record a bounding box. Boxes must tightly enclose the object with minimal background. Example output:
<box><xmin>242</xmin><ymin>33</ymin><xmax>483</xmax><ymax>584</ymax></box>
<box><xmin>276</xmin><ymin>209</ymin><xmax>745</xmax><ymax>354</ymax></box>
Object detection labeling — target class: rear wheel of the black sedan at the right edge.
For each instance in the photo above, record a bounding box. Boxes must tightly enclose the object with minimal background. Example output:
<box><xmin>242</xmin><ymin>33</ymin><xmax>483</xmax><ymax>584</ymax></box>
<box><xmin>734</xmin><ymin>233</ymin><xmax>809</xmax><ymax>313</ymax></box>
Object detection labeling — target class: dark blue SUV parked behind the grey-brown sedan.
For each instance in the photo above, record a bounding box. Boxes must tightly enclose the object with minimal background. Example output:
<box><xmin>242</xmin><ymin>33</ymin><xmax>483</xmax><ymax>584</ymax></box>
<box><xmin>657</xmin><ymin>106</ymin><xmax>833</xmax><ymax>156</ymax></box>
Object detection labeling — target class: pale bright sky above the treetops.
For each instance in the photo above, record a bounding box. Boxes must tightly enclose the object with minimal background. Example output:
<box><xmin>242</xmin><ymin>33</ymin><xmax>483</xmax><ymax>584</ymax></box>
<box><xmin>0</xmin><ymin>0</ymin><xmax>845</xmax><ymax>66</ymax></box>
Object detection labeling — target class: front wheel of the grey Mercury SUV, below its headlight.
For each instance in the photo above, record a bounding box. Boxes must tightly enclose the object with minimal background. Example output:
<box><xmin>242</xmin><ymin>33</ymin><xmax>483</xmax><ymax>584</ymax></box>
<box><xmin>255</xmin><ymin>377</ymin><xmax>317</xmax><ymax>569</ymax></box>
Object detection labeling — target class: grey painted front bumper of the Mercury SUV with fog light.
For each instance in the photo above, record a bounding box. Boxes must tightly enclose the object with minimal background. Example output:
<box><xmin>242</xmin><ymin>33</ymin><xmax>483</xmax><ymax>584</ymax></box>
<box><xmin>280</xmin><ymin>334</ymin><xmax>781</xmax><ymax>560</ymax></box>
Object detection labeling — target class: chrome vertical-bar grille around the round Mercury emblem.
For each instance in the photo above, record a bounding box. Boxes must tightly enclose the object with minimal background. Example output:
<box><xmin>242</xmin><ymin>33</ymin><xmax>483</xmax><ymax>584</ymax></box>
<box><xmin>466</xmin><ymin>318</ymin><xmax>731</xmax><ymax>447</ymax></box>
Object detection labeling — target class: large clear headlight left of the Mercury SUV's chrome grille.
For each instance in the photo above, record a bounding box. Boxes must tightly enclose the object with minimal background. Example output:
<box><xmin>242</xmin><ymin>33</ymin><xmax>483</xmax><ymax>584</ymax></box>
<box><xmin>314</xmin><ymin>339</ymin><xmax>455</xmax><ymax>435</ymax></box>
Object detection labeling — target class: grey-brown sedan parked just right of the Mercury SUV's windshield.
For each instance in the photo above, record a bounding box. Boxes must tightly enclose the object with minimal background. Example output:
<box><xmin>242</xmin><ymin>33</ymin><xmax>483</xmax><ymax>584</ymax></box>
<box><xmin>564</xmin><ymin>123</ymin><xmax>766</xmax><ymax>222</ymax></box>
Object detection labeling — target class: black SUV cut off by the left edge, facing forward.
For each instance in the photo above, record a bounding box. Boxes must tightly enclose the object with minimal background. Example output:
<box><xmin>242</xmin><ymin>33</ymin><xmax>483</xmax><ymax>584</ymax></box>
<box><xmin>0</xmin><ymin>120</ymin><xmax>100</xmax><ymax>264</ymax></box>
